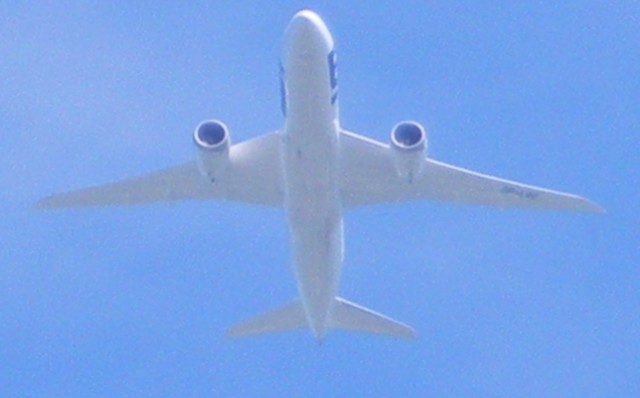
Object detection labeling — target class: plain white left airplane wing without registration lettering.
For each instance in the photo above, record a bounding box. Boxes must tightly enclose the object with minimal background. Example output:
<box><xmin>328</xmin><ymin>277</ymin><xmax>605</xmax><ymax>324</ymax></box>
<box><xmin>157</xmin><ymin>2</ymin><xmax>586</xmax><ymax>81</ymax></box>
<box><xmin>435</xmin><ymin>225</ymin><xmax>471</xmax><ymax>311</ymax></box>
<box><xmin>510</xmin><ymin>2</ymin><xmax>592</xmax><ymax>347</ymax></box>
<box><xmin>36</xmin><ymin>132</ymin><xmax>284</xmax><ymax>208</ymax></box>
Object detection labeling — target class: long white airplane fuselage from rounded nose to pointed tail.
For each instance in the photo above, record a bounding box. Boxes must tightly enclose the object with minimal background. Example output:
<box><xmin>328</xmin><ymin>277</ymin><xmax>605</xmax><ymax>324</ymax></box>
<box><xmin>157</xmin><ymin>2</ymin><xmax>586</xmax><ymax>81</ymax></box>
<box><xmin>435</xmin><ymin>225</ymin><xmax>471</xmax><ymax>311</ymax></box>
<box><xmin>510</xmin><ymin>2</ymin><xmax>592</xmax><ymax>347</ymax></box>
<box><xmin>281</xmin><ymin>12</ymin><xmax>344</xmax><ymax>339</ymax></box>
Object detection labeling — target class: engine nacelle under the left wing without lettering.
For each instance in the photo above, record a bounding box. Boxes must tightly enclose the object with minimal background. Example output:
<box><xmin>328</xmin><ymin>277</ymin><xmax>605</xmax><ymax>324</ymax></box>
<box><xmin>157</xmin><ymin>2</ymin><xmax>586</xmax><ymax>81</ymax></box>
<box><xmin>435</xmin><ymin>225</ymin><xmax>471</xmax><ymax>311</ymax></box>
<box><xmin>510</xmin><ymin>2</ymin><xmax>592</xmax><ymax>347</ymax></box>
<box><xmin>193</xmin><ymin>120</ymin><xmax>231</xmax><ymax>182</ymax></box>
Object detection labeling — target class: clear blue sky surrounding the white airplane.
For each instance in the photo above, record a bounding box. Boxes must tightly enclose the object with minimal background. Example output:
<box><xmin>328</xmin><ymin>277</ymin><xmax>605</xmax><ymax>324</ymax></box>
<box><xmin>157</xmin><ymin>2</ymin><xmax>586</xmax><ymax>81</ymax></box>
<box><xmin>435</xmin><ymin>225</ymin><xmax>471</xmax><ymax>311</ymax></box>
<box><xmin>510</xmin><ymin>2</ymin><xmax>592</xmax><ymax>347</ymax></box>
<box><xmin>0</xmin><ymin>0</ymin><xmax>640</xmax><ymax>397</ymax></box>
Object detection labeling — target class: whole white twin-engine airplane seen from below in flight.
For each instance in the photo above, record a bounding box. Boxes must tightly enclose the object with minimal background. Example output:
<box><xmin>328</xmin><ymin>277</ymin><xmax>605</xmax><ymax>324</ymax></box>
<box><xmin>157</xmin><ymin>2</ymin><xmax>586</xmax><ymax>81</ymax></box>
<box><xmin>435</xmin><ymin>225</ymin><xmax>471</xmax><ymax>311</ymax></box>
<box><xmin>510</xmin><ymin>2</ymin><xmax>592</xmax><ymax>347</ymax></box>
<box><xmin>37</xmin><ymin>10</ymin><xmax>603</xmax><ymax>342</ymax></box>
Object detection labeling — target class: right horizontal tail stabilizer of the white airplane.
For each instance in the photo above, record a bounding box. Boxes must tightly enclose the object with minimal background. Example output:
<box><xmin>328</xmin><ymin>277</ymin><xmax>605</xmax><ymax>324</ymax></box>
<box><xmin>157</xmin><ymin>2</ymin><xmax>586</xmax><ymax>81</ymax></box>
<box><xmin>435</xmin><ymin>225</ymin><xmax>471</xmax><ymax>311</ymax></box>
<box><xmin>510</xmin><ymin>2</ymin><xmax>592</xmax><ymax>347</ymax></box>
<box><xmin>329</xmin><ymin>297</ymin><xmax>417</xmax><ymax>339</ymax></box>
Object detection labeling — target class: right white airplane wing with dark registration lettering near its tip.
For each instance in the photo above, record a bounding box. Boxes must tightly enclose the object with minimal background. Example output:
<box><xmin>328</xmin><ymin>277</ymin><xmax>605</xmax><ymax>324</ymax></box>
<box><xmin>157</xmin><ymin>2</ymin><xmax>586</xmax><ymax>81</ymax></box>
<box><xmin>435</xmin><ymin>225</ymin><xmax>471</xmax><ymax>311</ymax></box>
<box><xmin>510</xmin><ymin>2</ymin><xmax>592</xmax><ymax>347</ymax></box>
<box><xmin>340</xmin><ymin>131</ymin><xmax>604</xmax><ymax>212</ymax></box>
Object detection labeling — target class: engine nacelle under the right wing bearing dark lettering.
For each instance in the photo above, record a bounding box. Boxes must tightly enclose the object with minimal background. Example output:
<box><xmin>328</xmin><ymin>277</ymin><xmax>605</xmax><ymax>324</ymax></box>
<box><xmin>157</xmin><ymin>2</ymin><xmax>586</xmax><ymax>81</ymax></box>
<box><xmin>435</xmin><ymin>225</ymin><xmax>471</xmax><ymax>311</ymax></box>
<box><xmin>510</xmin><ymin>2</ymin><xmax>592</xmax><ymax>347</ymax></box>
<box><xmin>391</xmin><ymin>121</ymin><xmax>427</xmax><ymax>182</ymax></box>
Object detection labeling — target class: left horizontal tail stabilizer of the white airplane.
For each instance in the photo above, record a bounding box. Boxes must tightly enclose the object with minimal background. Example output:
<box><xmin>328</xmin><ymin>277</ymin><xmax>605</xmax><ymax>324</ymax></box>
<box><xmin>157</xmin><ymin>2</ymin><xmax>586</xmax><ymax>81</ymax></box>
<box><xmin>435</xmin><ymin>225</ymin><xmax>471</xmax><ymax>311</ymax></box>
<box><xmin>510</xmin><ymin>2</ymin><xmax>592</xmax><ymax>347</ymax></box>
<box><xmin>227</xmin><ymin>300</ymin><xmax>307</xmax><ymax>337</ymax></box>
